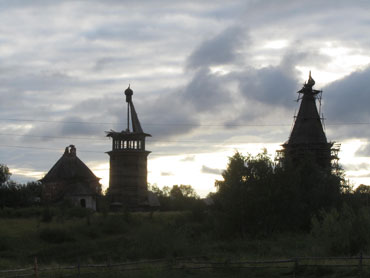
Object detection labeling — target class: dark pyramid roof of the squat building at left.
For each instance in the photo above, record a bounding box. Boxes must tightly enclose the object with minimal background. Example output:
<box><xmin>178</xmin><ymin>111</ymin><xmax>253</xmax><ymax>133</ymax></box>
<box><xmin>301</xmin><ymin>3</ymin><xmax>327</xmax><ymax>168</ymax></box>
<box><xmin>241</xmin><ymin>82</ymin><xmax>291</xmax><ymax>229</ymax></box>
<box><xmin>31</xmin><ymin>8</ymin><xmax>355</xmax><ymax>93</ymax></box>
<box><xmin>41</xmin><ymin>145</ymin><xmax>99</xmax><ymax>182</ymax></box>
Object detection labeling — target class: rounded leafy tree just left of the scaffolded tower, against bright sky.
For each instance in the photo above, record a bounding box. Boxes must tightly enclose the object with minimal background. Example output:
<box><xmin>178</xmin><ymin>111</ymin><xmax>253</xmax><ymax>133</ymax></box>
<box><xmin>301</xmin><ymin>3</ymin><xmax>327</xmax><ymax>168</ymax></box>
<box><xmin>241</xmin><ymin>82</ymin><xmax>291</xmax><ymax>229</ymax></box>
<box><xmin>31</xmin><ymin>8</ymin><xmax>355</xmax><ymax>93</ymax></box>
<box><xmin>214</xmin><ymin>150</ymin><xmax>274</xmax><ymax>236</ymax></box>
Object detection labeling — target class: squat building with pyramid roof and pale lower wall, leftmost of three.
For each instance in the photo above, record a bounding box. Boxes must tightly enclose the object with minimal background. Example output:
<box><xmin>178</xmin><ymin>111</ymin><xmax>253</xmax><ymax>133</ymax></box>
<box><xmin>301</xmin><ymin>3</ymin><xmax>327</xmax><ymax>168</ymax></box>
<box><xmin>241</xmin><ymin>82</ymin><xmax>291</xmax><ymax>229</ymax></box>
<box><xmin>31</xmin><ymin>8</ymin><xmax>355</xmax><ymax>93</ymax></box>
<box><xmin>40</xmin><ymin>145</ymin><xmax>101</xmax><ymax>210</ymax></box>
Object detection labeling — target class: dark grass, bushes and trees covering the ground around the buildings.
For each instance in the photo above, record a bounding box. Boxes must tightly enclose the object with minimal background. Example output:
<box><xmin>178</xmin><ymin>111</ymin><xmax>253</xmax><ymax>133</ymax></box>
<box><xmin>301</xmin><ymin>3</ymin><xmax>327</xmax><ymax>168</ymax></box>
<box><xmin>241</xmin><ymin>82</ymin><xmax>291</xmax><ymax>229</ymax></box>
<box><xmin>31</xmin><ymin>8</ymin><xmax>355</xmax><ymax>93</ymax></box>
<box><xmin>0</xmin><ymin>152</ymin><xmax>370</xmax><ymax>277</ymax></box>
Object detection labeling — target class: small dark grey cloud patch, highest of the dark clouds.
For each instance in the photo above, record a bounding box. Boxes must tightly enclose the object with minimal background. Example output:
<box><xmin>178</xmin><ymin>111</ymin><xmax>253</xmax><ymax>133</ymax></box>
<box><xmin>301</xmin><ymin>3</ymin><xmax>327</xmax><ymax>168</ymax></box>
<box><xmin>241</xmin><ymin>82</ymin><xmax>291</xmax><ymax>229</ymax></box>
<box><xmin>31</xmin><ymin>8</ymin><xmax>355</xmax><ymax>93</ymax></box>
<box><xmin>187</xmin><ymin>26</ymin><xmax>243</xmax><ymax>69</ymax></box>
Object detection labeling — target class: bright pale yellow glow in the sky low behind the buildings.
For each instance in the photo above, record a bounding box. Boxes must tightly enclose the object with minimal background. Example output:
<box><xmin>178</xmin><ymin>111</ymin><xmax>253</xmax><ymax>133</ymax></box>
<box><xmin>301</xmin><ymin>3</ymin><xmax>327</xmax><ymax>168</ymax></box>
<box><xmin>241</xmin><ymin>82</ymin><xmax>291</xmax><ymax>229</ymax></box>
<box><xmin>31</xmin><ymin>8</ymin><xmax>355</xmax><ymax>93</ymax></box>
<box><xmin>6</xmin><ymin>140</ymin><xmax>370</xmax><ymax>197</ymax></box>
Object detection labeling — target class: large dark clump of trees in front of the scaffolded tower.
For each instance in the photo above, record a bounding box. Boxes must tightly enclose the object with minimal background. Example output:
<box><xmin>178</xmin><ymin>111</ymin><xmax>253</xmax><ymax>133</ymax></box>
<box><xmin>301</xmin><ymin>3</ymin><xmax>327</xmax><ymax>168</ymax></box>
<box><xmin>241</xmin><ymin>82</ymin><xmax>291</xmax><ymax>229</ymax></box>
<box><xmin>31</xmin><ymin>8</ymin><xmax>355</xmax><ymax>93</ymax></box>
<box><xmin>214</xmin><ymin>150</ymin><xmax>342</xmax><ymax>236</ymax></box>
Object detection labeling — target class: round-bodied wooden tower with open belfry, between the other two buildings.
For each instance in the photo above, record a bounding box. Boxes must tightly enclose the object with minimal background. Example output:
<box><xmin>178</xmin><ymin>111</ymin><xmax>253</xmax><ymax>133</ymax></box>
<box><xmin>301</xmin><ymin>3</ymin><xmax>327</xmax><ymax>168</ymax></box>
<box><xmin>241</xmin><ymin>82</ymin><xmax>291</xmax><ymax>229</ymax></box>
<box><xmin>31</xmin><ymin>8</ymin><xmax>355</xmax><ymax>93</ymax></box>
<box><xmin>107</xmin><ymin>86</ymin><xmax>151</xmax><ymax>209</ymax></box>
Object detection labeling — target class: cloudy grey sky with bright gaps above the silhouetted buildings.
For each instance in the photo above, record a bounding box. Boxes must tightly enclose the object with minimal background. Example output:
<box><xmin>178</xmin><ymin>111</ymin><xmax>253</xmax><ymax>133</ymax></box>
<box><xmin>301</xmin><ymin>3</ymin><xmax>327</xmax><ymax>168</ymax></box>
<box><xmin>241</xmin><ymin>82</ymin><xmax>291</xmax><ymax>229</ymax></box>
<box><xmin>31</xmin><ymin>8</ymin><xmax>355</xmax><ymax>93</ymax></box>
<box><xmin>0</xmin><ymin>0</ymin><xmax>370</xmax><ymax>196</ymax></box>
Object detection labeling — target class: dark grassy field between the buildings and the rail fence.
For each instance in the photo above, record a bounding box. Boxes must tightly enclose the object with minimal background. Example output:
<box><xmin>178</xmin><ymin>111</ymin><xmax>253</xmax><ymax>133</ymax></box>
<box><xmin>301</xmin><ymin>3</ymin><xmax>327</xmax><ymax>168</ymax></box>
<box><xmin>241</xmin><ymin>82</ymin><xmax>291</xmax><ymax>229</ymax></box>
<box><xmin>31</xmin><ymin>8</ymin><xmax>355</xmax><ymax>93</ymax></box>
<box><xmin>0</xmin><ymin>206</ymin><xmax>368</xmax><ymax>277</ymax></box>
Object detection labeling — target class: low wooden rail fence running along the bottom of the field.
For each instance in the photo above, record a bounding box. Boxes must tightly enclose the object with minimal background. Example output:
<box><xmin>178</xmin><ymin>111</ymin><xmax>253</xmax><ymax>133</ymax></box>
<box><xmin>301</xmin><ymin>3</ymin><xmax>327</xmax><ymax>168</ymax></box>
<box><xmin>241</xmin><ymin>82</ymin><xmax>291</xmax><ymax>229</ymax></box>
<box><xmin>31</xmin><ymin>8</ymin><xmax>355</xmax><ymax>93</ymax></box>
<box><xmin>0</xmin><ymin>254</ymin><xmax>370</xmax><ymax>278</ymax></box>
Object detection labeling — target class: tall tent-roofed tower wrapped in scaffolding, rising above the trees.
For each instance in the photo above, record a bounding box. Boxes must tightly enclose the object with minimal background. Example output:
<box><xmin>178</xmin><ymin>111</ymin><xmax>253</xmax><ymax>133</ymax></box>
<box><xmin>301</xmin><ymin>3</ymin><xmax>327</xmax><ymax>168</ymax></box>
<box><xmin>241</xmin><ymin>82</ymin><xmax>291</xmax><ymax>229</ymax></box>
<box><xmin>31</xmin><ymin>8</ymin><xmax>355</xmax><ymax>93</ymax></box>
<box><xmin>278</xmin><ymin>72</ymin><xmax>340</xmax><ymax>170</ymax></box>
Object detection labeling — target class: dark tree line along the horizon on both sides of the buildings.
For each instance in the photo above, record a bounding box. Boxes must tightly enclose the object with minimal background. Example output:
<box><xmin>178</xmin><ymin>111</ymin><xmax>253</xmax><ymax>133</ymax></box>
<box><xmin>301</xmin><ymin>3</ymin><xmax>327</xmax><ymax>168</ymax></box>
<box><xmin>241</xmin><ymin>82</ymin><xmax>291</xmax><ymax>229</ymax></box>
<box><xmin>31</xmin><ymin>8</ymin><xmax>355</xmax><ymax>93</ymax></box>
<box><xmin>0</xmin><ymin>151</ymin><xmax>370</xmax><ymax>254</ymax></box>
